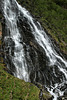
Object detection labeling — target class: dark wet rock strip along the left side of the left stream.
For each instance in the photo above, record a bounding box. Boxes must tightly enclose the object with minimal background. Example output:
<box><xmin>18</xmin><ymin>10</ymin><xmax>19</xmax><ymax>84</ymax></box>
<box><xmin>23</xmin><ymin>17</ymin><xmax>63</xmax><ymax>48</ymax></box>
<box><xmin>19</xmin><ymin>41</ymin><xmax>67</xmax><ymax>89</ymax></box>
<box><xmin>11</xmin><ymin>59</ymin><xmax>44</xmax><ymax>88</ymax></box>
<box><xmin>2</xmin><ymin>19</ymin><xmax>16</xmax><ymax>75</ymax></box>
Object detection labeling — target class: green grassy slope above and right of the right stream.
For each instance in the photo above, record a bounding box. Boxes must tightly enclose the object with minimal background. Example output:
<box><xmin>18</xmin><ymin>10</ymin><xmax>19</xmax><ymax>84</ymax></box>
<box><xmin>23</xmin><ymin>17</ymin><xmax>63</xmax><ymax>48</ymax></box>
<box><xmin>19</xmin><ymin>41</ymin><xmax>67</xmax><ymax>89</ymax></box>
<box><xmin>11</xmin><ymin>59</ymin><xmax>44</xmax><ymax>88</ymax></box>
<box><xmin>17</xmin><ymin>0</ymin><xmax>67</xmax><ymax>54</ymax></box>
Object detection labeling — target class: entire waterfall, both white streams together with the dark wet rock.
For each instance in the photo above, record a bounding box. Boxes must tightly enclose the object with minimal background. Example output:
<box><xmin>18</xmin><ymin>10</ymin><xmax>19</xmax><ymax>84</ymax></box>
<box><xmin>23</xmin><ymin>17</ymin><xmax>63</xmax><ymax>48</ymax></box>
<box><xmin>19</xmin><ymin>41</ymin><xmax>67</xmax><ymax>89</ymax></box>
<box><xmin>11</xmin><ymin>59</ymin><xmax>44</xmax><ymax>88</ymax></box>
<box><xmin>1</xmin><ymin>0</ymin><xmax>67</xmax><ymax>100</ymax></box>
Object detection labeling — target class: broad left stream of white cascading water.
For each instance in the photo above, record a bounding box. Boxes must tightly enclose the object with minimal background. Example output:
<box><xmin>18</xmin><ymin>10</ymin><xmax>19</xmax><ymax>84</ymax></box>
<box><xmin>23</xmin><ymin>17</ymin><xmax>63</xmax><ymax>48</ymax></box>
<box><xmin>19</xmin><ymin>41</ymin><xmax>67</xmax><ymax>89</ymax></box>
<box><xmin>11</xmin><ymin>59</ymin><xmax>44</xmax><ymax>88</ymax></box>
<box><xmin>4</xmin><ymin>0</ymin><xmax>29</xmax><ymax>81</ymax></box>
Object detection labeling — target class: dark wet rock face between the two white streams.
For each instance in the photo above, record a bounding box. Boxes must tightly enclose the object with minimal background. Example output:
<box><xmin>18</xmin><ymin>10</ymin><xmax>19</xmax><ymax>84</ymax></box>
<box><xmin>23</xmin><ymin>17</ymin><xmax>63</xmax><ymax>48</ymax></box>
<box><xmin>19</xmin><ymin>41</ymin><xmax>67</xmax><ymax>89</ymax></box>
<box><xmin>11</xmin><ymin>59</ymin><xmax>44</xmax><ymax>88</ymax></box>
<box><xmin>17</xmin><ymin>15</ymin><xmax>66</xmax><ymax>86</ymax></box>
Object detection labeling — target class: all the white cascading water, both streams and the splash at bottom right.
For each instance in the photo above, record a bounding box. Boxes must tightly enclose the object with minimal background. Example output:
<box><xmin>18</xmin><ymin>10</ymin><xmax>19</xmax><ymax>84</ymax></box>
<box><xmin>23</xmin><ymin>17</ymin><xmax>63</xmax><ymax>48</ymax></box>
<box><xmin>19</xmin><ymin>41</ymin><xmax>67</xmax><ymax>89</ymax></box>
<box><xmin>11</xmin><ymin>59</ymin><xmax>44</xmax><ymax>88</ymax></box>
<box><xmin>3</xmin><ymin>0</ymin><xmax>67</xmax><ymax>100</ymax></box>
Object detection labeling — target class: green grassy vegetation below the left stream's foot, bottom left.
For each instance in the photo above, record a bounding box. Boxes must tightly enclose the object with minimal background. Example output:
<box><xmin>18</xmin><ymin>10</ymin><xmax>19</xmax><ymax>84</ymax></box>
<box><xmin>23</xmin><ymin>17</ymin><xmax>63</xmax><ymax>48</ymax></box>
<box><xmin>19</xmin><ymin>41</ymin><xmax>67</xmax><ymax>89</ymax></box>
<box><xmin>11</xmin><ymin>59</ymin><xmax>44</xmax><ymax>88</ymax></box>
<box><xmin>0</xmin><ymin>64</ymin><xmax>40</xmax><ymax>100</ymax></box>
